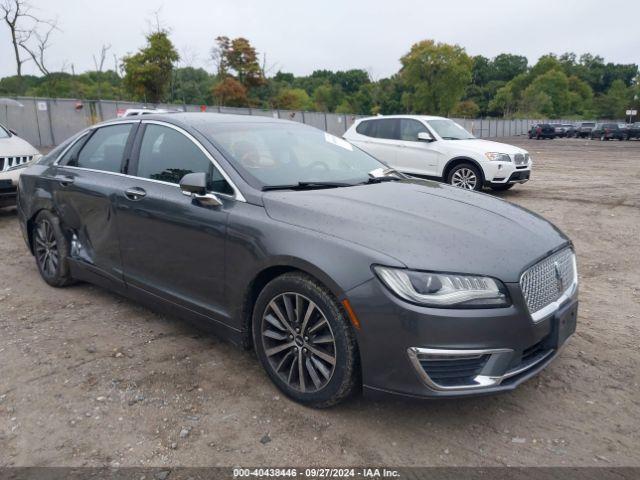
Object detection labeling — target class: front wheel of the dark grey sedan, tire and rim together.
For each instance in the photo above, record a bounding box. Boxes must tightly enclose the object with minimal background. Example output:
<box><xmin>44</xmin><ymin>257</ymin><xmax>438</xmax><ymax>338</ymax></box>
<box><xmin>252</xmin><ymin>273</ymin><xmax>360</xmax><ymax>408</ymax></box>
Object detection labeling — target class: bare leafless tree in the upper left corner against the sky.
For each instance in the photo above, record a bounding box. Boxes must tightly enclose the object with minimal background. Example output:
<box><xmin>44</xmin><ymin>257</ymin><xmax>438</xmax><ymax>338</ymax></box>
<box><xmin>0</xmin><ymin>0</ymin><xmax>58</xmax><ymax>77</ymax></box>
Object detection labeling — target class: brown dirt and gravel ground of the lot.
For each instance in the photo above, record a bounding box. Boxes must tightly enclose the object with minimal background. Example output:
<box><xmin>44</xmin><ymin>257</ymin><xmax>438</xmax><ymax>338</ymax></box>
<box><xmin>0</xmin><ymin>138</ymin><xmax>640</xmax><ymax>466</ymax></box>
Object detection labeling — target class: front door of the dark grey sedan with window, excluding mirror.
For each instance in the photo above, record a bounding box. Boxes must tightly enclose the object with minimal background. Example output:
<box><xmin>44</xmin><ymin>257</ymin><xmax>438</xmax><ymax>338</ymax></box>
<box><xmin>117</xmin><ymin>121</ymin><xmax>236</xmax><ymax>320</ymax></box>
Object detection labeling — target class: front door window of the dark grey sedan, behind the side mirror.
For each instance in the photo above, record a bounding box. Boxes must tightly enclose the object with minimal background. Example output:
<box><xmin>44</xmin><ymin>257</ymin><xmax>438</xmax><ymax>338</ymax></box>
<box><xmin>137</xmin><ymin>123</ymin><xmax>233</xmax><ymax>194</ymax></box>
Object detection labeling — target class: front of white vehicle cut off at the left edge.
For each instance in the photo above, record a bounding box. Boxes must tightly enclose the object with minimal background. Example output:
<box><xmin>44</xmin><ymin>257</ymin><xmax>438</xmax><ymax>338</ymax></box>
<box><xmin>0</xmin><ymin>124</ymin><xmax>41</xmax><ymax>208</ymax></box>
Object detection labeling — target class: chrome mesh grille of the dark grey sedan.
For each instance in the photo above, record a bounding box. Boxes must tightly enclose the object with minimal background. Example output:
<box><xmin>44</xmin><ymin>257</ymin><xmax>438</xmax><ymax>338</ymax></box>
<box><xmin>520</xmin><ymin>248</ymin><xmax>577</xmax><ymax>319</ymax></box>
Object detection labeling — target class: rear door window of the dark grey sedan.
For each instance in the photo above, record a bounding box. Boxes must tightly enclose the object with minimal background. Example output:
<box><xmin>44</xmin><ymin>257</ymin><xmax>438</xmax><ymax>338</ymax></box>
<box><xmin>69</xmin><ymin>123</ymin><xmax>133</xmax><ymax>173</ymax></box>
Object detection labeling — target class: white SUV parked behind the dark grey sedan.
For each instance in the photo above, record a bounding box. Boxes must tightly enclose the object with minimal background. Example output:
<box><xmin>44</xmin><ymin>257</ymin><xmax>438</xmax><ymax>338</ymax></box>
<box><xmin>344</xmin><ymin>115</ymin><xmax>531</xmax><ymax>190</ymax></box>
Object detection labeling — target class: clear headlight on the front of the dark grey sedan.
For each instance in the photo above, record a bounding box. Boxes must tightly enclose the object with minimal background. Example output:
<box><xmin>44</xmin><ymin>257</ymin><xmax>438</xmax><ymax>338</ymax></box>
<box><xmin>373</xmin><ymin>266</ymin><xmax>510</xmax><ymax>308</ymax></box>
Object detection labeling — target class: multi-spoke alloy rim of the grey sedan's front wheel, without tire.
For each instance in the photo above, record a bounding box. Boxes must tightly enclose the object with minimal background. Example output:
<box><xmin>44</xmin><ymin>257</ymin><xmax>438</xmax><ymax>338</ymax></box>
<box><xmin>260</xmin><ymin>292</ymin><xmax>336</xmax><ymax>393</ymax></box>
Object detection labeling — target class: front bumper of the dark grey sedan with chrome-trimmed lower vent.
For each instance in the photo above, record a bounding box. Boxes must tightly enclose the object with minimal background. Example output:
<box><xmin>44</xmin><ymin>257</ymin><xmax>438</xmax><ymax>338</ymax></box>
<box><xmin>348</xmin><ymin>279</ymin><xmax>578</xmax><ymax>398</ymax></box>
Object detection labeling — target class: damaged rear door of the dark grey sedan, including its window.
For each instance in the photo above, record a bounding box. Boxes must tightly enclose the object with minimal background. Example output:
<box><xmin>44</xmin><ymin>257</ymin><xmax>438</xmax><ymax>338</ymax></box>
<box><xmin>51</xmin><ymin>121</ymin><xmax>138</xmax><ymax>289</ymax></box>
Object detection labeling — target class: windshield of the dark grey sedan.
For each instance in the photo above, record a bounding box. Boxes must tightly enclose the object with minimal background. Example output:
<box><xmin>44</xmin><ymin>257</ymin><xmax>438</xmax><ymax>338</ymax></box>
<box><xmin>198</xmin><ymin>123</ymin><xmax>387</xmax><ymax>188</ymax></box>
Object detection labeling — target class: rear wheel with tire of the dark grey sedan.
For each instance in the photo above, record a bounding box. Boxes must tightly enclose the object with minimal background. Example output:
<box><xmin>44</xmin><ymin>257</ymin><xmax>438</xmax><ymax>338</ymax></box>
<box><xmin>33</xmin><ymin>210</ymin><xmax>73</xmax><ymax>287</ymax></box>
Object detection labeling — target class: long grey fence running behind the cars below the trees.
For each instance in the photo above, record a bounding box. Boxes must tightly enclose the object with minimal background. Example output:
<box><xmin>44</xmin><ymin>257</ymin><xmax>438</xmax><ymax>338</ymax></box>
<box><xmin>0</xmin><ymin>97</ymin><xmax>552</xmax><ymax>147</ymax></box>
